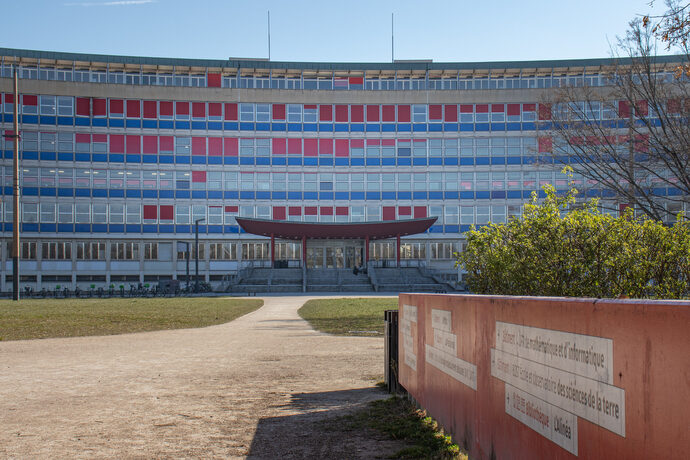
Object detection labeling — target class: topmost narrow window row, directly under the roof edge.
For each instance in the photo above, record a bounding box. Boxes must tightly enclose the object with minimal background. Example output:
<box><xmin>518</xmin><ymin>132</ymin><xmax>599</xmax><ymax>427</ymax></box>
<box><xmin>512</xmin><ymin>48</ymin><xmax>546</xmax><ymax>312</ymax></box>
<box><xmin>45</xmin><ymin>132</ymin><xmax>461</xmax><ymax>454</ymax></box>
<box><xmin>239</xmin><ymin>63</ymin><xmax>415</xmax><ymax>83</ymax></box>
<box><xmin>5</xmin><ymin>64</ymin><xmax>673</xmax><ymax>91</ymax></box>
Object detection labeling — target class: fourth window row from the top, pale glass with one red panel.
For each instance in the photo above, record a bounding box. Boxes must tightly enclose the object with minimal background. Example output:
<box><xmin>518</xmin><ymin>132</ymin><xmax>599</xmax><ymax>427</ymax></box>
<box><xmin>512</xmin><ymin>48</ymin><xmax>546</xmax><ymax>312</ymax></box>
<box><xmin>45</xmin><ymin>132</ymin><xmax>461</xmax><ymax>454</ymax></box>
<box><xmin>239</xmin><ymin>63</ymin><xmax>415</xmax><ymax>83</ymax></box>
<box><xmin>5</xmin><ymin>166</ymin><xmax>628</xmax><ymax>192</ymax></box>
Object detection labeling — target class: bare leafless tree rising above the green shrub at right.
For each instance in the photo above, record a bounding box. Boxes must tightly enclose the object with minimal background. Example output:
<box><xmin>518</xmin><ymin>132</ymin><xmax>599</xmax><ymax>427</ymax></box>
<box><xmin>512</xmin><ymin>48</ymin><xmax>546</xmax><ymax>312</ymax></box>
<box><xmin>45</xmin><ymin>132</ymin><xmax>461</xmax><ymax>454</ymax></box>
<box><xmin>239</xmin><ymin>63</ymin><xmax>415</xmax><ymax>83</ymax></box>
<box><xmin>540</xmin><ymin>8</ymin><xmax>690</xmax><ymax>220</ymax></box>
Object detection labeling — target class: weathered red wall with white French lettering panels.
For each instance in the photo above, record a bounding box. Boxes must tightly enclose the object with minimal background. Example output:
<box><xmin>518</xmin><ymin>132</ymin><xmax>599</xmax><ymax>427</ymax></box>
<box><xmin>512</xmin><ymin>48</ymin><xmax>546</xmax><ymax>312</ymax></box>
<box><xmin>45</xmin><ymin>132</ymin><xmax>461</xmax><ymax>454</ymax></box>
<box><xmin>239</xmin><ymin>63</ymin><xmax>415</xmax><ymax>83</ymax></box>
<box><xmin>399</xmin><ymin>294</ymin><xmax>690</xmax><ymax>459</ymax></box>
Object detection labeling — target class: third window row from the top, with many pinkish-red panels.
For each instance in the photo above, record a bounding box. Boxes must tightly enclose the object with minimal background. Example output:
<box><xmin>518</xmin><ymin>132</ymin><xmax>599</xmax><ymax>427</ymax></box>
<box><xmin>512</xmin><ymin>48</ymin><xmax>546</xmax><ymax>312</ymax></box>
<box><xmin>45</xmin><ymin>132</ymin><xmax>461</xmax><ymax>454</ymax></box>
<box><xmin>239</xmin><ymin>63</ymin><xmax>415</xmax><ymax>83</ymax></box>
<box><xmin>0</xmin><ymin>131</ymin><xmax>551</xmax><ymax>157</ymax></box>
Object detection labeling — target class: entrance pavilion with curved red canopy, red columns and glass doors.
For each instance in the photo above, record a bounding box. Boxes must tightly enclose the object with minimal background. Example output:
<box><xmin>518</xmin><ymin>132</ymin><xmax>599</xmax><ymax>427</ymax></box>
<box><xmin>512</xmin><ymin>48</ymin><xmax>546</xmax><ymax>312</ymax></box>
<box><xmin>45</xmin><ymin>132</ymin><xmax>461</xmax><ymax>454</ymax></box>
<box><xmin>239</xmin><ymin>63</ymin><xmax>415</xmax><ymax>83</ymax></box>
<box><xmin>236</xmin><ymin>217</ymin><xmax>438</xmax><ymax>268</ymax></box>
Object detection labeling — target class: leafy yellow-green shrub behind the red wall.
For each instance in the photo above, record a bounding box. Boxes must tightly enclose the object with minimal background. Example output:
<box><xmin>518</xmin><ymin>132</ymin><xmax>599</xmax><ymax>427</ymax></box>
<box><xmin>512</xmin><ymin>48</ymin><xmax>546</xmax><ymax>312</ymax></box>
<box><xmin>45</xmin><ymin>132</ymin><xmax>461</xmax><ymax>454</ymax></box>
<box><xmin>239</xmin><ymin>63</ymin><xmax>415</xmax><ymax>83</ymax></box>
<box><xmin>456</xmin><ymin>174</ymin><xmax>690</xmax><ymax>299</ymax></box>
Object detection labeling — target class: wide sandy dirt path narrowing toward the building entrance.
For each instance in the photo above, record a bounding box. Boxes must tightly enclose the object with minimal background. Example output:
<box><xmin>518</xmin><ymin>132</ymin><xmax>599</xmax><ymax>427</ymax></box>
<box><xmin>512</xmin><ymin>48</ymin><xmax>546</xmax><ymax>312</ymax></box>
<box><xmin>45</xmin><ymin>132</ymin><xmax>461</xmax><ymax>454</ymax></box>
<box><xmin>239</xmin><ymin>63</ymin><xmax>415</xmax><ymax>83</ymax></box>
<box><xmin>0</xmin><ymin>297</ymin><xmax>398</xmax><ymax>458</ymax></box>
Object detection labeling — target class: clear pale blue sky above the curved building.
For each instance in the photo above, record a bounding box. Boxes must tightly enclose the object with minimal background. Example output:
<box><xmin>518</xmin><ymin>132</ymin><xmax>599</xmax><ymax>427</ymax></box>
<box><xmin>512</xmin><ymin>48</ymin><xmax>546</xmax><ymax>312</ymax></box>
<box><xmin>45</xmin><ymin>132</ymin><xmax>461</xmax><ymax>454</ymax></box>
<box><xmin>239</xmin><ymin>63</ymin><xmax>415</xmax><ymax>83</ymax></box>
<box><xmin>0</xmin><ymin>0</ymin><xmax>664</xmax><ymax>62</ymax></box>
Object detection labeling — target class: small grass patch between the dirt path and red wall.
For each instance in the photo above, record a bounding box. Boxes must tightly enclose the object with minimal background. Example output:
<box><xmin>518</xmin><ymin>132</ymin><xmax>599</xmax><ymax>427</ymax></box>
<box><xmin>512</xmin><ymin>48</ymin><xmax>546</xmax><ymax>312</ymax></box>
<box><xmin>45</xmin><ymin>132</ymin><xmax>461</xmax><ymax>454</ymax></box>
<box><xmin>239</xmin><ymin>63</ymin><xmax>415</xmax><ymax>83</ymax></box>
<box><xmin>298</xmin><ymin>297</ymin><xmax>398</xmax><ymax>336</ymax></box>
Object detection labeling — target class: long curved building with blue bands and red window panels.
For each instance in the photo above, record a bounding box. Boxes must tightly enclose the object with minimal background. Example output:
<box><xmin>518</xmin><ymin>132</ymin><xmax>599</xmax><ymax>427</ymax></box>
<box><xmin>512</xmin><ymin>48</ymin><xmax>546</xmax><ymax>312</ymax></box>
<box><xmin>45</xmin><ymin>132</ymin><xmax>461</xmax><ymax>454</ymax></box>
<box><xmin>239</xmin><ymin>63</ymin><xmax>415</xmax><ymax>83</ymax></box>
<box><xmin>0</xmin><ymin>49</ymin><xmax>680</xmax><ymax>291</ymax></box>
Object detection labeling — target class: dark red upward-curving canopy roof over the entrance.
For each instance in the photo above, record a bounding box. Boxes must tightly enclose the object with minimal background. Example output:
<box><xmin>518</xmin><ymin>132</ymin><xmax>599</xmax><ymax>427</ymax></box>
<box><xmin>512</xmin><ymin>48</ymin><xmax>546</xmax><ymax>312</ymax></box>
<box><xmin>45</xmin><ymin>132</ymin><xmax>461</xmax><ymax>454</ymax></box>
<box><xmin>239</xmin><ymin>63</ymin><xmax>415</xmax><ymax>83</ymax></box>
<box><xmin>236</xmin><ymin>217</ymin><xmax>438</xmax><ymax>240</ymax></box>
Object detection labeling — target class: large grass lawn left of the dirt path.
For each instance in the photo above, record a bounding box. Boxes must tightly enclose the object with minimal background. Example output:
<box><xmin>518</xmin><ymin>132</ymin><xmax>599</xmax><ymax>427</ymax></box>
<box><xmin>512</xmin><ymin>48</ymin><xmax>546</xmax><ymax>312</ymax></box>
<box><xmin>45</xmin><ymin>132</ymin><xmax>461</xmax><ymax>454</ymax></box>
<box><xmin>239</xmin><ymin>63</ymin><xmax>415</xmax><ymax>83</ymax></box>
<box><xmin>0</xmin><ymin>297</ymin><xmax>263</xmax><ymax>340</ymax></box>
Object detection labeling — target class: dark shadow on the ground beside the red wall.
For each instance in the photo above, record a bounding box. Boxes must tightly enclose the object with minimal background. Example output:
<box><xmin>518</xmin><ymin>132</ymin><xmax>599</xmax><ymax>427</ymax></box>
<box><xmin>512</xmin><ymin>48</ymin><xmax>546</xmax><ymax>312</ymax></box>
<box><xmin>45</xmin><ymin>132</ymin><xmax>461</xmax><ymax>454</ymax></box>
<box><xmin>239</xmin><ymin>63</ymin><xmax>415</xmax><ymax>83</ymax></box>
<box><xmin>247</xmin><ymin>387</ymin><xmax>401</xmax><ymax>459</ymax></box>
